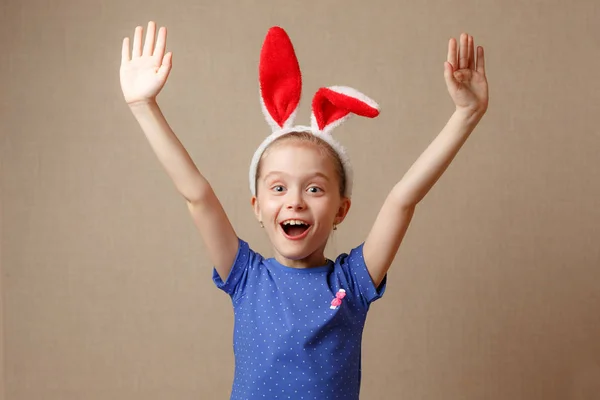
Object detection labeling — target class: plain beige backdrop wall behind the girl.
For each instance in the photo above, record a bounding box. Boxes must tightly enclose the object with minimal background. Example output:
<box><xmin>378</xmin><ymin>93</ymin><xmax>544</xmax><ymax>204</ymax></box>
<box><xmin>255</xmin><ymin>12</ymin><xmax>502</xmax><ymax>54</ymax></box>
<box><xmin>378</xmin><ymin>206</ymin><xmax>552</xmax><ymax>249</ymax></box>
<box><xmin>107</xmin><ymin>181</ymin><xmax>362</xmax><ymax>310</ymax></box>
<box><xmin>0</xmin><ymin>0</ymin><xmax>600</xmax><ymax>400</ymax></box>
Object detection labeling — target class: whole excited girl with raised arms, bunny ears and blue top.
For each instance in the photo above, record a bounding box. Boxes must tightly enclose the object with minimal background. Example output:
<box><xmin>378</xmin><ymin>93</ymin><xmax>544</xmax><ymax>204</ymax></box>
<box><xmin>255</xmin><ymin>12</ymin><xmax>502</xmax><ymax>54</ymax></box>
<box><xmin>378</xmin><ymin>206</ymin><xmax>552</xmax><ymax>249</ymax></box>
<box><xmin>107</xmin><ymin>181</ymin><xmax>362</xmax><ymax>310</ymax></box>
<box><xmin>121</xmin><ymin>22</ymin><xmax>488</xmax><ymax>400</ymax></box>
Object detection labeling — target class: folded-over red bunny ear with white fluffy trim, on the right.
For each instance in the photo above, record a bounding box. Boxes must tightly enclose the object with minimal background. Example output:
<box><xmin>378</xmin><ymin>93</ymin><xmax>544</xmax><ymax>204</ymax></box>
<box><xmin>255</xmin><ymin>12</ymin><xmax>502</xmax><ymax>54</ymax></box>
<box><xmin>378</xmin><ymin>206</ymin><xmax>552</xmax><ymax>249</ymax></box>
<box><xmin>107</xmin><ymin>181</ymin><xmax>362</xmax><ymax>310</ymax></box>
<box><xmin>312</xmin><ymin>86</ymin><xmax>379</xmax><ymax>132</ymax></box>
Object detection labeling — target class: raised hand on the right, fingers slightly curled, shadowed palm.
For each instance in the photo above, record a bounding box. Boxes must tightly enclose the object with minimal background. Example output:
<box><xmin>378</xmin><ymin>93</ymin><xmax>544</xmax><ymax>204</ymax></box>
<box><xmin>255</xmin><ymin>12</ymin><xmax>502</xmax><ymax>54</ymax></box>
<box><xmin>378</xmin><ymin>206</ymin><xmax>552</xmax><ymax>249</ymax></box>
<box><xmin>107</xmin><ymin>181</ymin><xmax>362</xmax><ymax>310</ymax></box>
<box><xmin>444</xmin><ymin>33</ymin><xmax>488</xmax><ymax>115</ymax></box>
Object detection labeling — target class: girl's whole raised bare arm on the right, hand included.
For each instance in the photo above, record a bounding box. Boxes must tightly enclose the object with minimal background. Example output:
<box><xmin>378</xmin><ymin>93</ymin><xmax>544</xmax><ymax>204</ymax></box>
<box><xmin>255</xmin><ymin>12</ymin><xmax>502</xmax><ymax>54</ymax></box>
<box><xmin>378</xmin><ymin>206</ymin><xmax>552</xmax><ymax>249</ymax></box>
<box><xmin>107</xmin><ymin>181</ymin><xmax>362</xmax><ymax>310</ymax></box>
<box><xmin>363</xmin><ymin>33</ymin><xmax>488</xmax><ymax>286</ymax></box>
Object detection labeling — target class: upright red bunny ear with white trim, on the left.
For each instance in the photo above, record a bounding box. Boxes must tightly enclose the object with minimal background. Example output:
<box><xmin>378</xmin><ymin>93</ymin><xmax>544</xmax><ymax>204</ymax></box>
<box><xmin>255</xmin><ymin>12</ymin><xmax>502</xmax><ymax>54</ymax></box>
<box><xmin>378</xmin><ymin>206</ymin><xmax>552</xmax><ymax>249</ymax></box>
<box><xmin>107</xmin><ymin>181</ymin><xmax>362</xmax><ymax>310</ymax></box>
<box><xmin>259</xmin><ymin>26</ymin><xmax>302</xmax><ymax>131</ymax></box>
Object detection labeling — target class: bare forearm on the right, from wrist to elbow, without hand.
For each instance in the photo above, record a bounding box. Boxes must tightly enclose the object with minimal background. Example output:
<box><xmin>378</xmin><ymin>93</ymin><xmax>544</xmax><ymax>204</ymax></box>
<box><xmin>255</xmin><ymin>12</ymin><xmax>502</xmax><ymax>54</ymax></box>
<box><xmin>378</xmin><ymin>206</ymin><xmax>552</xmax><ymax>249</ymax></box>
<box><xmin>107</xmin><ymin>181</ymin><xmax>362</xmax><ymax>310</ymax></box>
<box><xmin>392</xmin><ymin>111</ymin><xmax>483</xmax><ymax>207</ymax></box>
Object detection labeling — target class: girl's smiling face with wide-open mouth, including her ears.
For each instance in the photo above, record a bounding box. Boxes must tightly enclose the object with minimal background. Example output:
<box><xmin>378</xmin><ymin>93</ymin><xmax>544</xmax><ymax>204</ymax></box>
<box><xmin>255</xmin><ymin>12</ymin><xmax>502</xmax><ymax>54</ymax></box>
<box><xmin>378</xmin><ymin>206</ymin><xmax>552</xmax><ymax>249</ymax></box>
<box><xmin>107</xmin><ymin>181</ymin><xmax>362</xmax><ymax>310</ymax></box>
<box><xmin>252</xmin><ymin>141</ymin><xmax>350</xmax><ymax>268</ymax></box>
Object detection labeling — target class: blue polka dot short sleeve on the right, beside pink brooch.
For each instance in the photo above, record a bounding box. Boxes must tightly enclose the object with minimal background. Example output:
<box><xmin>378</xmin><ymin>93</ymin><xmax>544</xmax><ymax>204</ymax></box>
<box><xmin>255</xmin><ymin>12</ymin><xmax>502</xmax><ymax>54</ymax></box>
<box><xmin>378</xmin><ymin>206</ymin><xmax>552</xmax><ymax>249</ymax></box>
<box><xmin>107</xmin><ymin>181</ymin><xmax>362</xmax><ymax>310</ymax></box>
<box><xmin>337</xmin><ymin>243</ymin><xmax>387</xmax><ymax>307</ymax></box>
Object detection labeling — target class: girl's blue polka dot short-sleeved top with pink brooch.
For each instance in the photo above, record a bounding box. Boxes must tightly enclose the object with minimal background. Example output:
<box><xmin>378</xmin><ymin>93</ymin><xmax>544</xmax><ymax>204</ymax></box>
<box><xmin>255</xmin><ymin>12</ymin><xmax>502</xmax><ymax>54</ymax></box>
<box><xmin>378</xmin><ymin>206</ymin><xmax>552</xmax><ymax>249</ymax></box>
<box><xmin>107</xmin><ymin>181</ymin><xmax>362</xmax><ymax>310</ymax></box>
<box><xmin>213</xmin><ymin>240</ymin><xmax>386</xmax><ymax>400</ymax></box>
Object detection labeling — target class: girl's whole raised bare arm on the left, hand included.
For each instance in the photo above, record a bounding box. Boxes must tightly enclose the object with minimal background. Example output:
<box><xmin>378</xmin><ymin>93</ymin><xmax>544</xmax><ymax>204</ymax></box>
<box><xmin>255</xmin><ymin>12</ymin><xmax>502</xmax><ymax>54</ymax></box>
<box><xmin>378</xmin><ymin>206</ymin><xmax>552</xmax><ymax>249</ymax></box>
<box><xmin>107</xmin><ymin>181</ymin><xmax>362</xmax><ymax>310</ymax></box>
<box><xmin>120</xmin><ymin>22</ymin><xmax>238</xmax><ymax>280</ymax></box>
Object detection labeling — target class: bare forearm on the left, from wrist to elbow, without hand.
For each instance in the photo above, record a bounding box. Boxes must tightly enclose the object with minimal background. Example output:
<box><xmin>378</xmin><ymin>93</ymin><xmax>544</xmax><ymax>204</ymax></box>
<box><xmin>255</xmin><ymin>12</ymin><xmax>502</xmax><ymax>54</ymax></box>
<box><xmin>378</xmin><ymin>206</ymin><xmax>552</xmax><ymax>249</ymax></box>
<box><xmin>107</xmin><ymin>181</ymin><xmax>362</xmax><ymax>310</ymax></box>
<box><xmin>130</xmin><ymin>101</ymin><xmax>210</xmax><ymax>202</ymax></box>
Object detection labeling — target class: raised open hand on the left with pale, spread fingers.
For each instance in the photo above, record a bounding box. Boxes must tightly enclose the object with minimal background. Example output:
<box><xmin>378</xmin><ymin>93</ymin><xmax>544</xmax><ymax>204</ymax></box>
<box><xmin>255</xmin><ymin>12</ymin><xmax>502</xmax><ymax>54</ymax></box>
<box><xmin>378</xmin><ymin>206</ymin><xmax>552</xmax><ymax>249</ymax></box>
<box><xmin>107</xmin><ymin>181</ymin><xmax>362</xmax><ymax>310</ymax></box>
<box><xmin>120</xmin><ymin>21</ymin><xmax>172</xmax><ymax>105</ymax></box>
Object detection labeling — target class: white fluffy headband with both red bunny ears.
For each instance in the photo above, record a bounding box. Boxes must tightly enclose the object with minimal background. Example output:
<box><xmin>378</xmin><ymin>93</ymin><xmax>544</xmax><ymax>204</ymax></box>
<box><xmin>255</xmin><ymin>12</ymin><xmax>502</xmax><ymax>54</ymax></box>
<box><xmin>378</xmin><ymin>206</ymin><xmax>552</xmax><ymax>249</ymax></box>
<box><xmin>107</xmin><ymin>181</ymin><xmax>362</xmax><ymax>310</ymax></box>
<box><xmin>250</xmin><ymin>27</ymin><xmax>379</xmax><ymax>197</ymax></box>
